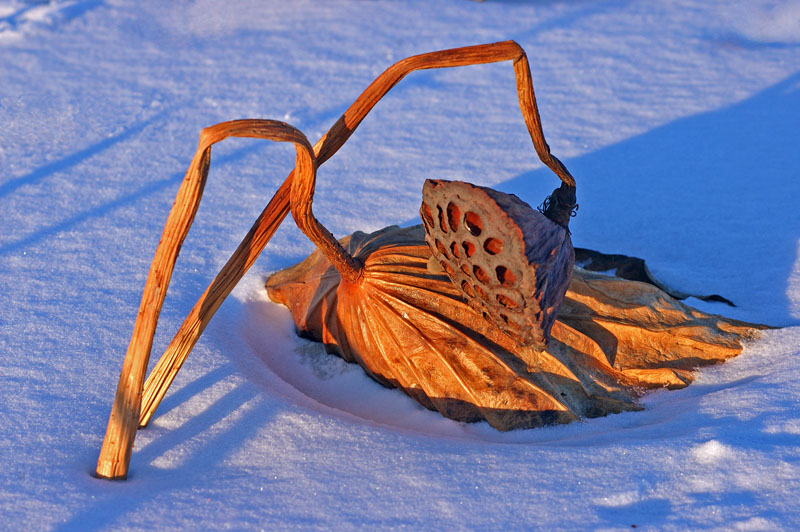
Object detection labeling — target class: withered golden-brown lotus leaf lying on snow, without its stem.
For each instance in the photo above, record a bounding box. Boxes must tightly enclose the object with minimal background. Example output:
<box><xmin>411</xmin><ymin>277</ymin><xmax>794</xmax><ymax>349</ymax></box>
<box><xmin>266</xmin><ymin>224</ymin><xmax>758</xmax><ymax>430</ymax></box>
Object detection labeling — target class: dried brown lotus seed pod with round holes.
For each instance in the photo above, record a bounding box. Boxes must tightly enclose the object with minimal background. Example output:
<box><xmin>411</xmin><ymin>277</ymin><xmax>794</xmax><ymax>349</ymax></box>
<box><xmin>420</xmin><ymin>179</ymin><xmax>575</xmax><ymax>349</ymax></box>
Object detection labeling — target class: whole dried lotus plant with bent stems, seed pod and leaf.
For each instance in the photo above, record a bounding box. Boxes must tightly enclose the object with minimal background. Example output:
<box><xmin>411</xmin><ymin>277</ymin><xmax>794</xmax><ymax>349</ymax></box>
<box><xmin>97</xmin><ymin>41</ymin><xmax>753</xmax><ymax>479</ymax></box>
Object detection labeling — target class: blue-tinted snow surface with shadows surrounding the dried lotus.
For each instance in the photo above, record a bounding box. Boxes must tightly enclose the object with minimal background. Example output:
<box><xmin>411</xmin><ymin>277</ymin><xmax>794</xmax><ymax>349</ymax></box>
<box><xmin>0</xmin><ymin>0</ymin><xmax>800</xmax><ymax>531</ymax></box>
